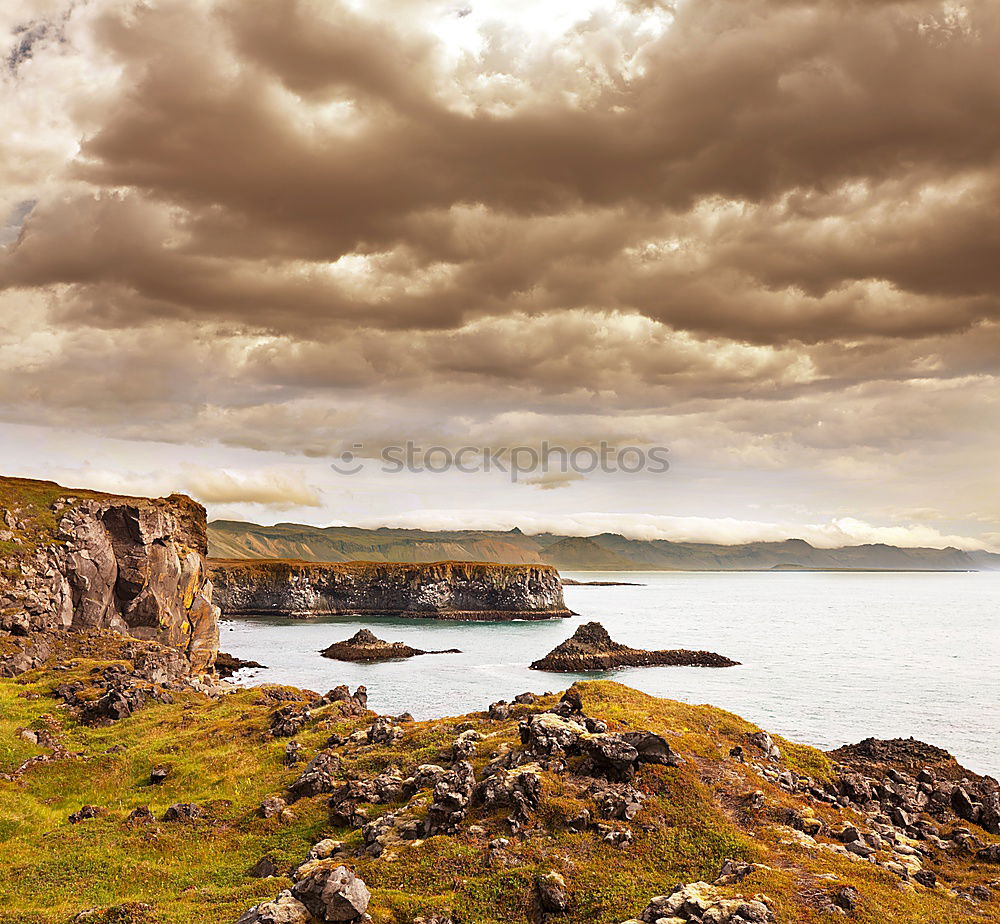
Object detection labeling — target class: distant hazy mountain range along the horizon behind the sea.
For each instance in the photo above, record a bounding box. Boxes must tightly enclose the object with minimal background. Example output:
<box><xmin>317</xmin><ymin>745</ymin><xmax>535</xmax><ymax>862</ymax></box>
<box><xmin>208</xmin><ymin>520</ymin><xmax>1000</xmax><ymax>571</ymax></box>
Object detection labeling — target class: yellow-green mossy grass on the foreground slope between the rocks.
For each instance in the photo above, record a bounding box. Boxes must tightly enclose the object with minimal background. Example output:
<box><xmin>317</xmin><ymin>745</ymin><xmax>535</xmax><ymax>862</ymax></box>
<box><xmin>0</xmin><ymin>662</ymin><xmax>1000</xmax><ymax>924</ymax></box>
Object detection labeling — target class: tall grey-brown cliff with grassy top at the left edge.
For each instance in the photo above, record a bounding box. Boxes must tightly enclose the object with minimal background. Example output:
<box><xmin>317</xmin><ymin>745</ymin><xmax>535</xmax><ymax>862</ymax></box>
<box><xmin>0</xmin><ymin>478</ymin><xmax>219</xmax><ymax>672</ymax></box>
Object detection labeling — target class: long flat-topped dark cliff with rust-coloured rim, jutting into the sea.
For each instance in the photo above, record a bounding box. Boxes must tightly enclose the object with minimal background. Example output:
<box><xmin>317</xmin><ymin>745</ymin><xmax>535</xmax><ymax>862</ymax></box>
<box><xmin>211</xmin><ymin>561</ymin><xmax>570</xmax><ymax>620</ymax></box>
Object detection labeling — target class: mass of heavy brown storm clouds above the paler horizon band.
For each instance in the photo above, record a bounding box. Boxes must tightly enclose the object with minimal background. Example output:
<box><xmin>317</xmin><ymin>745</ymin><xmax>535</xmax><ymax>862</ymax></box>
<box><xmin>0</xmin><ymin>0</ymin><xmax>1000</xmax><ymax>476</ymax></box>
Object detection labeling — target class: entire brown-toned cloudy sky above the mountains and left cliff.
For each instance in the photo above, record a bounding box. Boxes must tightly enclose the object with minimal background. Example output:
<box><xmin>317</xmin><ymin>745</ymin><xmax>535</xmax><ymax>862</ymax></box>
<box><xmin>0</xmin><ymin>0</ymin><xmax>1000</xmax><ymax>548</ymax></box>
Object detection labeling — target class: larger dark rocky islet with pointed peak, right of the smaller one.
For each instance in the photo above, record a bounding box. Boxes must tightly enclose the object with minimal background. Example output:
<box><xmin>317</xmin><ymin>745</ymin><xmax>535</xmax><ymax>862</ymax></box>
<box><xmin>531</xmin><ymin>622</ymin><xmax>739</xmax><ymax>671</ymax></box>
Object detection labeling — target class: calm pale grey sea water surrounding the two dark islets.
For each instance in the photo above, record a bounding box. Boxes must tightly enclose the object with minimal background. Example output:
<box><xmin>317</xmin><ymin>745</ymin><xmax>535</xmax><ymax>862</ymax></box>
<box><xmin>222</xmin><ymin>572</ymin><xmax>1000</xmax><ymax>777</ymax></box>
